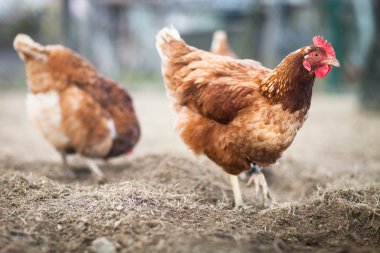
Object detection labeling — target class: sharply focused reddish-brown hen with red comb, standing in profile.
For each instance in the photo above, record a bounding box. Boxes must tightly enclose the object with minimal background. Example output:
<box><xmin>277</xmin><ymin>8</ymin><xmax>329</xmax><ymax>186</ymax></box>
<box><xmin>156</xmin><ymin>28</ymin><xmax>339</xmax><ymax>206</ymax></box>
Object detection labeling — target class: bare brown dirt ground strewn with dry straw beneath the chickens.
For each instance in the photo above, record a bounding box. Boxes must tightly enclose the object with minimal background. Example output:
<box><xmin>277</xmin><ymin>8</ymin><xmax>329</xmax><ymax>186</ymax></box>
<box><xmin>0</xmin><ymin>91</ymin><xmax>380</xmax><ymax>253</ymax></box>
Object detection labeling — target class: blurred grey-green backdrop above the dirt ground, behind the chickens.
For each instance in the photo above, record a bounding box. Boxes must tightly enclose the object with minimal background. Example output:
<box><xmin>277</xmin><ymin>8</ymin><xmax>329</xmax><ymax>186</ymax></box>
<box><xmin>0</xmin><ymin>0</ymin><xmax>380</xmax><ymax>110</ymax></box>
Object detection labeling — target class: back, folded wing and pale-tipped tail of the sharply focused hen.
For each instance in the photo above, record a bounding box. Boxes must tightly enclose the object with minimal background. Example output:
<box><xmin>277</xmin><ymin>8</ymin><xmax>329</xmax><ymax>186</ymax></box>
<box><xmin>156</xmin><ymin>28</ymin><xmax>271</xmax><ymax>110</ymax></box>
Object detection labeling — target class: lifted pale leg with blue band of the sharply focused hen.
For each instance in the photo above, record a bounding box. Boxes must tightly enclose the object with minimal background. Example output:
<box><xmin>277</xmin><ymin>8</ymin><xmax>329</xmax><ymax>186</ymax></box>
<box><xmin>247</xmin><ymin>165</ymin><xmax>272</xmax><ymax>205</ymax></box>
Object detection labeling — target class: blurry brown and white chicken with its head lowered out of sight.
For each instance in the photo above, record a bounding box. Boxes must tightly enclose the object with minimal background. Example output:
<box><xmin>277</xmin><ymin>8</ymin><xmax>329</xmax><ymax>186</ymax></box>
<box><xmin>13</xmin><ymin>34</ymin><xmax>140</xmax><ymax>183</ymax></box>
